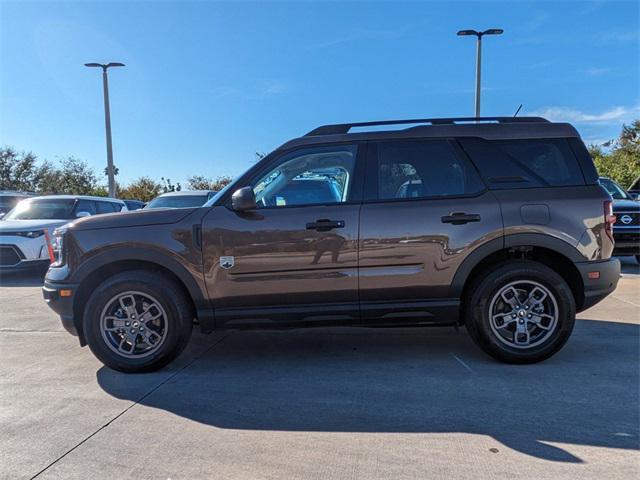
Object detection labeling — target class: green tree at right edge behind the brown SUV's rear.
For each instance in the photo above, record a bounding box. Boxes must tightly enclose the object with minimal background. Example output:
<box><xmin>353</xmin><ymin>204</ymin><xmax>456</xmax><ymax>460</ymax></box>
<box><xmin>589</xmin><ymin>120</ymin><xmax>640</xmax><ymax>188</ymax></box>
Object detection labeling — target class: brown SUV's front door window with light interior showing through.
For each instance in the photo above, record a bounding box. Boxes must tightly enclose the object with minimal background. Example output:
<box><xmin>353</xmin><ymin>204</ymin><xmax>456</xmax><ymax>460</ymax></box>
<box><xmin>253</xmin><ymin>145</ymin><xmax>357</xmax><ymax>208</ymax></box>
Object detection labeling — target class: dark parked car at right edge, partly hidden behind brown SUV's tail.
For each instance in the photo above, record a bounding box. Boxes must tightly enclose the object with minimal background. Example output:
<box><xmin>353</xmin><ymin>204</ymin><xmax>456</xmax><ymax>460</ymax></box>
<box><xmin>600</xmin><ymin>177</ymin><xmax>640</xmax><ymax>263</ymax></box>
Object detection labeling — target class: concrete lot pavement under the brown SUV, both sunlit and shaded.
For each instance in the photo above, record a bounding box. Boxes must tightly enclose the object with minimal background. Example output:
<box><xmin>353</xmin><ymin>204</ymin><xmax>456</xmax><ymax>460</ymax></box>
<box><xmin>0</xmin><ymin>261</ymin><xmax>640</xmax><ymax>479</ymax></box>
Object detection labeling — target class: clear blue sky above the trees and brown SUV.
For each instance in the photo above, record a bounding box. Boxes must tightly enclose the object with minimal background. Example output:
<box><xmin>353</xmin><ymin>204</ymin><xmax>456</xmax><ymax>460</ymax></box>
<box><xmin>0</xmin><ymin>1</ymin><xmax>640</xmax><ymax>186</ymax></box>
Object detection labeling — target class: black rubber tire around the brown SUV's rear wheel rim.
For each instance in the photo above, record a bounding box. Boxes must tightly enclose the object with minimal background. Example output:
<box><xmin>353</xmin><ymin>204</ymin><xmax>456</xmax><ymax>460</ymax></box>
<box><xmin>465</xmin><ymin>260</ymin><xmax>576</xmax><ymax>364</ymax></box>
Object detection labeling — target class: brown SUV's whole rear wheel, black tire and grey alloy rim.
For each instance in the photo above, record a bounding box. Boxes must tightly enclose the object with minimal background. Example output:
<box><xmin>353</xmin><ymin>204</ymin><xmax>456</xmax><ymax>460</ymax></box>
<box><xmin>465</xmin><ymin>260</ymin><xmax>576</xmax><ymax>363</ymax></box>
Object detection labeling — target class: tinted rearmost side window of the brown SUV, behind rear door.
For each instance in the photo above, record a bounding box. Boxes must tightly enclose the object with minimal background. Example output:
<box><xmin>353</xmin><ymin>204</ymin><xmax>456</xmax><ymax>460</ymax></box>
<box><xmin>459</xmin><ymin>138</ymin><xmax>585</xmax><ymax>189</ymax></box>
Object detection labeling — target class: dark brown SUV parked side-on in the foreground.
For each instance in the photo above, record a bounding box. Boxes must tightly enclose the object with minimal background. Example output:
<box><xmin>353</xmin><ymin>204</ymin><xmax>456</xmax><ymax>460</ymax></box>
<box><xmin>44</xmin><ymin>117</ymin><xmax>620</xmax><ymax>372</ymax></box>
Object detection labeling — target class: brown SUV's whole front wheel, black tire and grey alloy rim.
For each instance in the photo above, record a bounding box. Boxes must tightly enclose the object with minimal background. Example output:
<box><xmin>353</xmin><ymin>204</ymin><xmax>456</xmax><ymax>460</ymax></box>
<box><xmin>83</xmin><ymin>270</ymin><xmax>193</xmax><ymax>372</ymax></box>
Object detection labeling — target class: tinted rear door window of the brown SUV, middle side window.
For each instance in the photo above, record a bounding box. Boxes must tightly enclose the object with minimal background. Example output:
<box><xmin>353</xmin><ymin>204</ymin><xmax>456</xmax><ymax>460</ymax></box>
<box><xmin>378</xmin><ymin>140</ymin><xmax>485</xmax><ymax>200</ymax></box>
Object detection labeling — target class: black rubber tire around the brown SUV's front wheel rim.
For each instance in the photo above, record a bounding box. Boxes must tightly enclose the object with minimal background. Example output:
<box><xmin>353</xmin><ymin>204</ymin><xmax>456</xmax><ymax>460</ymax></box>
<box><xmin>83</xmin><ymin>270</ymin><xmax>194</xmax><ymax>373</ymax></box>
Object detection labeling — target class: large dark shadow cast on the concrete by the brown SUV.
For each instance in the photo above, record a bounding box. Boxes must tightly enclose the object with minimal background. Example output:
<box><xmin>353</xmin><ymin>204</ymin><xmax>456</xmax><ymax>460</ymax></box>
<box><xmin>97</xmin><ymin>320</ymin><xmax>639</xmax><ymax>463</ymax></box>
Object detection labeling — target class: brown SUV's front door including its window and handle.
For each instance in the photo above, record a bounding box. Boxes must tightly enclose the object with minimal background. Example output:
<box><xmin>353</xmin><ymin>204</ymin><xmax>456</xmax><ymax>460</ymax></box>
<box><xmin>203</xmin><ymin>145</ymin><xmax>361</xmax><ymax>326</ymax></box>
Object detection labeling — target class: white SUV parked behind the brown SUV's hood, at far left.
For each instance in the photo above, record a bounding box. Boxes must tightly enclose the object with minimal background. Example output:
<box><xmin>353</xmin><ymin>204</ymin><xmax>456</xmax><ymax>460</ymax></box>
<box><xmin>0</xmin><ymin>195</ymin><xmax>127</xmax><ymax>272</ymax></box>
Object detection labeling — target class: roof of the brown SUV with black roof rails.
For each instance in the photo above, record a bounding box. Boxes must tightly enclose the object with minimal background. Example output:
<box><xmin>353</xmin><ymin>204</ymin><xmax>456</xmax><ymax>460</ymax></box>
<box><xmin>280</xmin><ymin>117</ymin><xmax>580</xmax><ymax>149</ymax></box>
